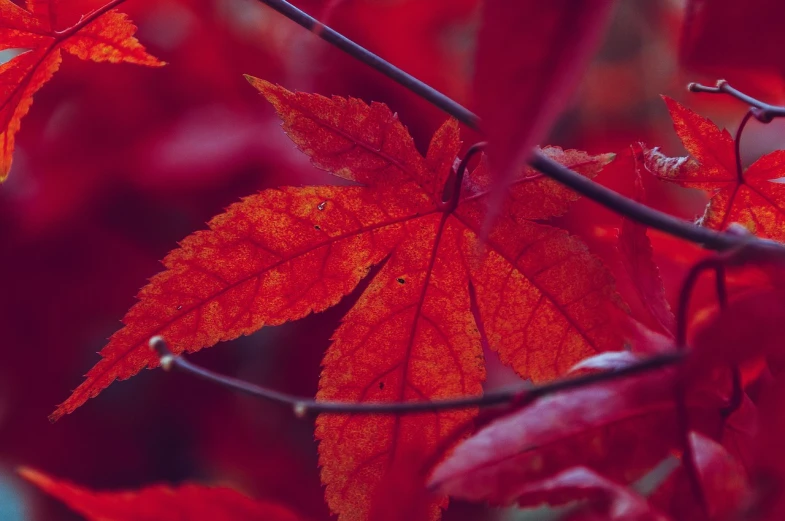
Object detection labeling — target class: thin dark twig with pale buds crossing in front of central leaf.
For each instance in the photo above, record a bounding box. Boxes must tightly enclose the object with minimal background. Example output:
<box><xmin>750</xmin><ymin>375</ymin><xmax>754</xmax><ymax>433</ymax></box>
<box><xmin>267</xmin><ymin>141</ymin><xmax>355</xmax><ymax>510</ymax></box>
<box><xmin>150</xmin><ymin>336</ymin><xmax>685</xmax><ymax>418</ymax></box>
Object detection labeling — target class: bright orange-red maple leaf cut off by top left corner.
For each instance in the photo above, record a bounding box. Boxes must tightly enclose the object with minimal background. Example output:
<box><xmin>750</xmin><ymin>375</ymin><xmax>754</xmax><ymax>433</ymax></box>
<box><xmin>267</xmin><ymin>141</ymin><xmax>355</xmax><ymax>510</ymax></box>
<box><xmin>0</xmin><ymin>0</ymin><xmax>164</xmax><ymax>182</ymax></box>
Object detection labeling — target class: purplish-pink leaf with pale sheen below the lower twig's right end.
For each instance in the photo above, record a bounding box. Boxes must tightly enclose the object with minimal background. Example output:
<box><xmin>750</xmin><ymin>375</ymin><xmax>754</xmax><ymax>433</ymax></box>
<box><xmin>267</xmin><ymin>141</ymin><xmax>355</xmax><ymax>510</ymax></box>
<box><xmin>431</xmin><ymin>355</ymin><xmax>726</xmax><ymax>504</ymax></box>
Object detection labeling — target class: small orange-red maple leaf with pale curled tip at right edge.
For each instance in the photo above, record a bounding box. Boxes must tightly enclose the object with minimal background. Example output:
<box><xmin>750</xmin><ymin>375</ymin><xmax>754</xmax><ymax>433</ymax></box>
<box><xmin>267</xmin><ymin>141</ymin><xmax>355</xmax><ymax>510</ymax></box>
<box><xmin>644</xmin><ymin>97</ymin><xmax>785</xmax><ymax>241</ymax></box>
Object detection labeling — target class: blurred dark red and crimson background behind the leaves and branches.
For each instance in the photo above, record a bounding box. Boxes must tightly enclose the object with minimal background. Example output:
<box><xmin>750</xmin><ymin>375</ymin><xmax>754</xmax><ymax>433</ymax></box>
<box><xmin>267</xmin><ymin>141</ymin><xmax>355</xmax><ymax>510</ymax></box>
<box><xmin>0</xmin><ymin>0</ymin><xmax>783</xmax><ymax>521</ymax></box>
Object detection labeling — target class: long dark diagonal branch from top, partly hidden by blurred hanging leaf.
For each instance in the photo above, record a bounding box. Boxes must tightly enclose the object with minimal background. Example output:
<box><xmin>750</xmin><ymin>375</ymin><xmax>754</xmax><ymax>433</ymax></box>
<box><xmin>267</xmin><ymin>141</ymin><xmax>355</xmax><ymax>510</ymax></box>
<box><xmin>248</xmin><ymin>0</ymin><xmax>785</xmax><ymax>256</ymax></box>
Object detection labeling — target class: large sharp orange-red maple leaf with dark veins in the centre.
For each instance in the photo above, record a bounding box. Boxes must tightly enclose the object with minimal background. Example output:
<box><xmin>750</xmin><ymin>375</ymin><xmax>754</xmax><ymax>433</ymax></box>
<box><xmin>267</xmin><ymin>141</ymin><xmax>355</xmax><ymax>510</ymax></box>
<box><xmin>52</xmin><ymin>78</ymin><xmax>621</xmax><ymax>521</ymax></box>
